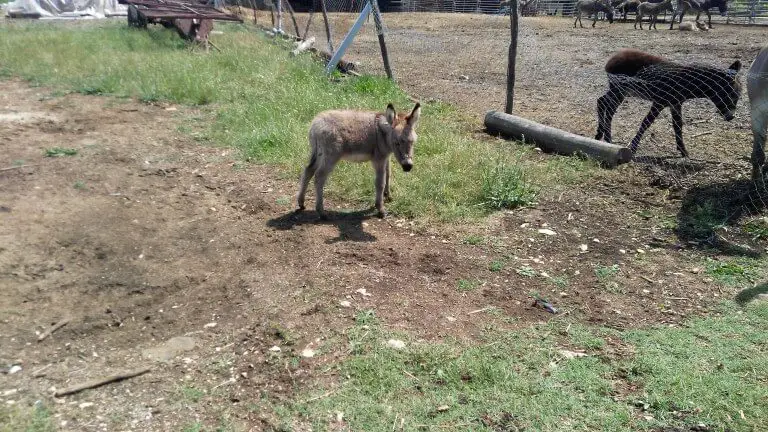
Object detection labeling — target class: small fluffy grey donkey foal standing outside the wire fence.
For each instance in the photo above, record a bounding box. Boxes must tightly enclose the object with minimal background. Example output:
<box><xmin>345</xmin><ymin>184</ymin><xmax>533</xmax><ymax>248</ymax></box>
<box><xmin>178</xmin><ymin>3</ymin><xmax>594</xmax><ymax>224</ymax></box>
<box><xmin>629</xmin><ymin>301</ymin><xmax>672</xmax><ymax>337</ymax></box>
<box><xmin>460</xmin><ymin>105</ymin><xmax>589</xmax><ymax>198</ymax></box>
<box><xmin>297</xmin><ymin>103</ymin><xmax>421</xmax><ymax>219</ymax></box>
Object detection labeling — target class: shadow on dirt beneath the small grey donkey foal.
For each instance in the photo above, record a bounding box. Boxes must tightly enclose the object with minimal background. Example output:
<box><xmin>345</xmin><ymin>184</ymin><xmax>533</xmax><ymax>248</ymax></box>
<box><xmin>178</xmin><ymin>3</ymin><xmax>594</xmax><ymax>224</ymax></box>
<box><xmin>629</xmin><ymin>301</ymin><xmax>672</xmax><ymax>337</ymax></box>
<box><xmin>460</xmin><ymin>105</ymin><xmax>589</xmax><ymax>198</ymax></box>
<box><xmin>267</xmin><ymin>209</ymin><xmax>376</xmax><ymax>244</ymax></box>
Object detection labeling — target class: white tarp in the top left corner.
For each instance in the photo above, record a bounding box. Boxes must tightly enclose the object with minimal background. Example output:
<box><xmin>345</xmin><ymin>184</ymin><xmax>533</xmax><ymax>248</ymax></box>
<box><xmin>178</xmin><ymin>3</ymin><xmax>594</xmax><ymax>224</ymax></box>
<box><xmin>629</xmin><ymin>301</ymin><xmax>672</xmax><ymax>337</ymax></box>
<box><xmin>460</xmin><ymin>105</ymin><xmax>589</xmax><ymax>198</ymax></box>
<box><xmin>4</xmin><ymin>0</ymin><xmax>128</xmax><ymax>18</ymax></box>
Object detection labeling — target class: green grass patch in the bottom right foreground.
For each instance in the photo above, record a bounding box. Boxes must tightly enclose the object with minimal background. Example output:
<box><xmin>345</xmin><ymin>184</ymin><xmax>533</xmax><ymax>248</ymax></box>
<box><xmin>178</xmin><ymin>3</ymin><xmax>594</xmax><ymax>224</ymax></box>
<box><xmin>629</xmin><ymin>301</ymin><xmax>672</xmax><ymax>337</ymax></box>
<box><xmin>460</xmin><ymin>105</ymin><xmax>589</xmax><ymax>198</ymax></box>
<box><xmin>289</xmin><ymin>305</ymin><xmax>768</xmax><ymax>432</ymax></box>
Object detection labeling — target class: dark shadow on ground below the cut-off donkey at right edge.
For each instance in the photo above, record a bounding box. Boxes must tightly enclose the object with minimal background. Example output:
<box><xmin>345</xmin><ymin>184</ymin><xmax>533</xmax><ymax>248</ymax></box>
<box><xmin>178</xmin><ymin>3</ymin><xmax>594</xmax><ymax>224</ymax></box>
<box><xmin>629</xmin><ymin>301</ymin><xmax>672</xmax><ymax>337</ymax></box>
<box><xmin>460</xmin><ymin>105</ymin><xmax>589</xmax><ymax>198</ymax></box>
<box><xmin>675</xmin><ymin>179</ymin><xmax>768</xmax><ymax>257</ymax></box>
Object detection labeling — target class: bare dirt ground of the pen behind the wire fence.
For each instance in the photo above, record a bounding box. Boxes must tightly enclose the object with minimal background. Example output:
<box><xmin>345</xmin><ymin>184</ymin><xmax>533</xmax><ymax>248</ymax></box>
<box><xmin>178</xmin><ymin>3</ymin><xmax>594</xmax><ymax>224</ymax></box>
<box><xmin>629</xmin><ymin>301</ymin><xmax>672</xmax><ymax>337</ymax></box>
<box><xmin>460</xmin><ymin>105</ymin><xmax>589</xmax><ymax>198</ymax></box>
<box><xmin>240</xmin><ymin>7</ymin><xmax>768</xmax><ymax>226</ymax></box>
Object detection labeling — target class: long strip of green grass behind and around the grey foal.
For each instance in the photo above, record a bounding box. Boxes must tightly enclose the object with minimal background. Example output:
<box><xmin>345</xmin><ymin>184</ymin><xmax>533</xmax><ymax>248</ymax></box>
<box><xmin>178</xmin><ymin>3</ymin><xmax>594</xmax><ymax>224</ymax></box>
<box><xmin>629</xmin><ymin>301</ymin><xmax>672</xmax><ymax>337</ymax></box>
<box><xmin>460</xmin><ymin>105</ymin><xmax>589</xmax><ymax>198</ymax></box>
<box><xmin>0</xmin><ymin>22</ymin><xmax>596</xmax><ymax>222</ymax></box>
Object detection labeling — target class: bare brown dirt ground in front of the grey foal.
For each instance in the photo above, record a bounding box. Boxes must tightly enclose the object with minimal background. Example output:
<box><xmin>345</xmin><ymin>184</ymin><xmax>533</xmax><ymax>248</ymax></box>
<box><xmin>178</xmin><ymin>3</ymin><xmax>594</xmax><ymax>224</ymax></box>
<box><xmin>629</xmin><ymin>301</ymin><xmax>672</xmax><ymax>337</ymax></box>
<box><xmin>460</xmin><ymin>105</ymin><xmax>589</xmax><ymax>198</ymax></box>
<box><xmin>0</xmin><ymin>82</ymin><xmax>756</xmax><ymax>431</ymax></box>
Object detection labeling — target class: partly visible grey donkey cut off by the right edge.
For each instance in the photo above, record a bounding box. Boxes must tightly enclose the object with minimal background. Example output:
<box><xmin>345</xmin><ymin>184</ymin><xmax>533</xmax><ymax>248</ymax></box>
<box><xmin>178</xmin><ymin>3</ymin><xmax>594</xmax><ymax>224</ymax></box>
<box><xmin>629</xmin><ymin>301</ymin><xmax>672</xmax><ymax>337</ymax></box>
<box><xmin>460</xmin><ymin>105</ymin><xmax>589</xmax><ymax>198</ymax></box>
<box><xmin>747</xmin><ymin>45</ymin><xmax>768</xmax><ymax>182</ymax></box>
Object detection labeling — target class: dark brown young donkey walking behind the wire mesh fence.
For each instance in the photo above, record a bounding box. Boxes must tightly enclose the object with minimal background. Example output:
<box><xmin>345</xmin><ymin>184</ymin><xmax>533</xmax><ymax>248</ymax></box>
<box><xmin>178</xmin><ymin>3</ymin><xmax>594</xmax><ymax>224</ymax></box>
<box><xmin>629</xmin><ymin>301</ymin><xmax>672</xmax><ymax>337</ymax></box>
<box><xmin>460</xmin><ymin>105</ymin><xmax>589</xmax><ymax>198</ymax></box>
<box><xmin>595</xmin><ymin>49</ymin><xmax>741</xmax><ymax>157</ymax></box>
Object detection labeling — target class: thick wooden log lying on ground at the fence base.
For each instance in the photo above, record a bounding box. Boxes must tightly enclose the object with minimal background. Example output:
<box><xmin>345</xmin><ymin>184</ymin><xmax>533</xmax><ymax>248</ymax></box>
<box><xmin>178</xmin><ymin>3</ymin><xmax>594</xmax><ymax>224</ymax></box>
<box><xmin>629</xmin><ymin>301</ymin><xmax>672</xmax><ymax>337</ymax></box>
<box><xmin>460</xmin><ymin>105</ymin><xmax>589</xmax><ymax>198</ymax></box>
<box><xmin>485</xmin><ymin>110</ymin><xmax>632</xmax><ymax>167</ymax></box>
